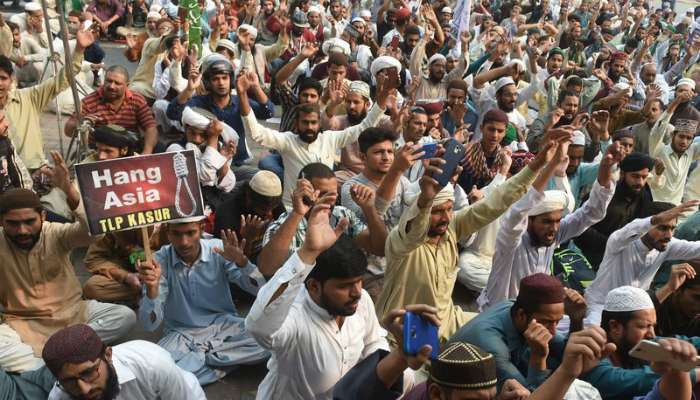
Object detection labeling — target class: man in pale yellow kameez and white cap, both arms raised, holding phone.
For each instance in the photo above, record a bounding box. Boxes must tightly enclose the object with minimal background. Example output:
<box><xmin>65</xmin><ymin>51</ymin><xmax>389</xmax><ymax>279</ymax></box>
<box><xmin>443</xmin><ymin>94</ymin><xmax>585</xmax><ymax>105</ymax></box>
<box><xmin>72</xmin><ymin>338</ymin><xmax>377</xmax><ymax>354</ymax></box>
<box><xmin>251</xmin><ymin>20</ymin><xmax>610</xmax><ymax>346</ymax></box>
<box><xmin>377</xmin><ymin>136</ymin><xmax>554</xmax><ymax>339</ymax></box>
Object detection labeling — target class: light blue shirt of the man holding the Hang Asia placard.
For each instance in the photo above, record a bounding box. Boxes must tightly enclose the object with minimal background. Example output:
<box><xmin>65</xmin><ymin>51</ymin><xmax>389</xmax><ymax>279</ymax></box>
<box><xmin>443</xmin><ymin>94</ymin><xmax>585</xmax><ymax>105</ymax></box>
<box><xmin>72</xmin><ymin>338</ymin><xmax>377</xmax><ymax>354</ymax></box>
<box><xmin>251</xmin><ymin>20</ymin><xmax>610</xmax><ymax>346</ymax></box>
<box><xmin>139</xmin><ymin>239</ymin><xmax>265</xmax><ymax>332</ymax></box>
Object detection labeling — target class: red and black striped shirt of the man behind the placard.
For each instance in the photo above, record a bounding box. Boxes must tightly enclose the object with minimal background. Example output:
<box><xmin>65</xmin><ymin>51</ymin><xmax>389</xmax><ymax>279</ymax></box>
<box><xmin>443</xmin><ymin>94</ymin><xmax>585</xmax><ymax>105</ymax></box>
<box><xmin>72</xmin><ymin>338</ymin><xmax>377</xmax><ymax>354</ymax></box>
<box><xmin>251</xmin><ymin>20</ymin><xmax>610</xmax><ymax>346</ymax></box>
<box><xmin>82</xmin><ymin>87</ymin><xmax>156</xmax><ymax>132</ymax></box>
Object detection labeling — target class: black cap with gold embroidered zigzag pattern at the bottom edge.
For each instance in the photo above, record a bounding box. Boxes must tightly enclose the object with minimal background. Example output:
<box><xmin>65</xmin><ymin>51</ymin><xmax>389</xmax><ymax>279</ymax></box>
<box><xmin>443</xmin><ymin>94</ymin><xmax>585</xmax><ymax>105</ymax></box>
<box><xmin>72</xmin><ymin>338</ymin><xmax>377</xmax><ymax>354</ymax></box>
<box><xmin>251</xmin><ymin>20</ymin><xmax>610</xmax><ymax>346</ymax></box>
<box><xmin>430</xmin><ymin>342</ymin><xmax>497</xmax><ymax>390</ymax></box>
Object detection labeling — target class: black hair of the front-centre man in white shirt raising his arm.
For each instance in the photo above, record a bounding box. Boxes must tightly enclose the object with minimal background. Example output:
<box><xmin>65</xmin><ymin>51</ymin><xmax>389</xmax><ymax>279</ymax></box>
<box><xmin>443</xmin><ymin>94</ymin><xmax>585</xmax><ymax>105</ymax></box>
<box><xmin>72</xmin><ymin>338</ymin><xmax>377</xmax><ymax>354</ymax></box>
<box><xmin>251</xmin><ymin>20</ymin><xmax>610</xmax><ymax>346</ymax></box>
<box><xmin>306</xmin><ymin>233</ymin><xmax>367</xmax><ymax>284</ymax></box>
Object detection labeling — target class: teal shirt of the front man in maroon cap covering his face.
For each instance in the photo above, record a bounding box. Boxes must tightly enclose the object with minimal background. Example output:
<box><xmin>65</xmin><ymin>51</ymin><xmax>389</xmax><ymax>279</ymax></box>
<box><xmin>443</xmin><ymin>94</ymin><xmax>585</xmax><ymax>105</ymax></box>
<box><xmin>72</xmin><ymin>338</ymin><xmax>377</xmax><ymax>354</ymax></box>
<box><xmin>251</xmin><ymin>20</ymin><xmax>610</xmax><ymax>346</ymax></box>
<box><xmin>449</xmin><ymin>300</ymin><xmax>566</xmax><ymax>390</ymax></box>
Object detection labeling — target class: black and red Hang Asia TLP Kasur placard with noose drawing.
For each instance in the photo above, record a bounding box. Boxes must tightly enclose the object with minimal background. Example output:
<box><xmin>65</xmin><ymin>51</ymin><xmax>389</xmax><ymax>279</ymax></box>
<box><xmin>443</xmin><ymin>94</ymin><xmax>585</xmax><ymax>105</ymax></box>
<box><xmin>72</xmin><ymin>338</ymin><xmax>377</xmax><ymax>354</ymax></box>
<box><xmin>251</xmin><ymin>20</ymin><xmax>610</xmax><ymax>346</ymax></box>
<box><xmin>75</xmin><ymin>150</ymin><xmax>204</xmax><ymax>235</ymax></box>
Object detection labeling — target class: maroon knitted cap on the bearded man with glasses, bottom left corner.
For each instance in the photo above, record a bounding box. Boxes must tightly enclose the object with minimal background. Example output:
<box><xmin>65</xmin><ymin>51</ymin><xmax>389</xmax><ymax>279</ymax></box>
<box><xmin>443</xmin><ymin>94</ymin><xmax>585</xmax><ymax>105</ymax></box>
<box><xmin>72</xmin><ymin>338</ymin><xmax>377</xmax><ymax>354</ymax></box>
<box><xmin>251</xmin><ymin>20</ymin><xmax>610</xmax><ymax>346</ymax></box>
<box><xmin>41</xmin><ymin>324</ymin><xmax>104</xmax><ymax>376</ymax></box>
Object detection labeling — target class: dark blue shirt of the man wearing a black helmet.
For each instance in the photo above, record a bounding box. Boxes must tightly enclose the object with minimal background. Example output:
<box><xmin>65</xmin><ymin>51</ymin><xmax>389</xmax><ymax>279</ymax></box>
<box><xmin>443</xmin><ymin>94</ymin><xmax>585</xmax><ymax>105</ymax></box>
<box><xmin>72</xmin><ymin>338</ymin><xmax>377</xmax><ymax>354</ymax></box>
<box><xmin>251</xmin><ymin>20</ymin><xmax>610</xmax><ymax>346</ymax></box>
<box><xmin>166</xmin><ymin>95</ymin><xmax>275</xmax><ymax>165</ymax></box>
